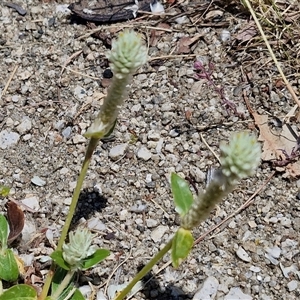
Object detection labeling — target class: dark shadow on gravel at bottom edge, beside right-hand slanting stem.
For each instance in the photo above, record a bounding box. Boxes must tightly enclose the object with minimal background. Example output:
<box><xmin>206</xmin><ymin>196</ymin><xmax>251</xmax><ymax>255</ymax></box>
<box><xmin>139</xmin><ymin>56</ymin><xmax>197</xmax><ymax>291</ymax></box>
<box><xmin>137</xmin><ymin>265</ymin><xmax>193</xmax><ymax>300</ymax></box>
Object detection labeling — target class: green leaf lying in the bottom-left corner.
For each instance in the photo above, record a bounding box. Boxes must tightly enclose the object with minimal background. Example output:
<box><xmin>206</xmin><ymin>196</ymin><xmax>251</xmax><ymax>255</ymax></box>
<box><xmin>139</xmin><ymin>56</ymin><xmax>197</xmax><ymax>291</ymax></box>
<box><xmin>0</xmin><ymin>284</ymin><xmax>37</xmax><ymax>300</ymax></box>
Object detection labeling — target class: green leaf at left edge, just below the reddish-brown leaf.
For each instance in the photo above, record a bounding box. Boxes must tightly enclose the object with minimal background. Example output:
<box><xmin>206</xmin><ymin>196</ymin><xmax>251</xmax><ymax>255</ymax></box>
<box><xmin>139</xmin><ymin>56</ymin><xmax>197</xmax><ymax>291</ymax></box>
<box><xmin>0</xmin><ymin>249</ymin><xmax>19</xmax><ymax>282</ymax></box>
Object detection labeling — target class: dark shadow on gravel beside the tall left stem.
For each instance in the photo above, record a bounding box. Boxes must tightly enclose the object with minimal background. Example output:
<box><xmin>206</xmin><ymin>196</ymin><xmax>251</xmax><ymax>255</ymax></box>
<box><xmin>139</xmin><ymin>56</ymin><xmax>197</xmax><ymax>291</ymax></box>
<box><xmin>72</xmin><ymin>188</ymin><xmax>107</xmax><ymax>227</ymax></box>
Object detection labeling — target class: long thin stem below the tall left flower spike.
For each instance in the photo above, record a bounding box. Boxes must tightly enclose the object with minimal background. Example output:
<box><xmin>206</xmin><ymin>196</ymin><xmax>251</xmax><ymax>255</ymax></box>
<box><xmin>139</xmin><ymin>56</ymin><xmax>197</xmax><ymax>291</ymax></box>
<box><xmin>39</xmin><ymin>138</ymin><xmax>99</xmax><ymax>300</ymax></box>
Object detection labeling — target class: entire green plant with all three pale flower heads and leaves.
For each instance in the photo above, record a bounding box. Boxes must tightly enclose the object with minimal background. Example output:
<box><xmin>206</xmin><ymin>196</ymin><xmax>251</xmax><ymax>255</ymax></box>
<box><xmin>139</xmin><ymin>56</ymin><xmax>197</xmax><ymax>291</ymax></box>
<box><xmin>0</xmin><ymin>30</ymin><xmax>260</xmax><ymax>300</ymax></box>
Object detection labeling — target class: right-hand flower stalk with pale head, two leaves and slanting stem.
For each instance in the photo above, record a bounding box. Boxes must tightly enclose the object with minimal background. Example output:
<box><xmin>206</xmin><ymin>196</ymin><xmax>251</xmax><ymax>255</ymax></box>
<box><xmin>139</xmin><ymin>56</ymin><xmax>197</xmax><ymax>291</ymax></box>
<box><xmin>114</xmin><ymin>132</ymin><xmax>261</xmax><ymax>300</ymax></box>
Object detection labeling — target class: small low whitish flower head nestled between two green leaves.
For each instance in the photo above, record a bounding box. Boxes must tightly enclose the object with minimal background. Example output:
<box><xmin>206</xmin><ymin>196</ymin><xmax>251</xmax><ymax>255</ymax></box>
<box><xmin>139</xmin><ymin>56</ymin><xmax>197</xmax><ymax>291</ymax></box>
<box><xmin>62</xmin><ymin>228</ymin><xmax>98</xmax><ymax>269</ymax></box>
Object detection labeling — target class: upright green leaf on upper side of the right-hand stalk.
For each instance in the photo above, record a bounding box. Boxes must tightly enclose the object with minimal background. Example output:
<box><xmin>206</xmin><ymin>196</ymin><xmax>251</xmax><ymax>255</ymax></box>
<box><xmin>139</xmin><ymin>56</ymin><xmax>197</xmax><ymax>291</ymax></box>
<box><xmin>171</xmin><ymin>173</ymin><xmax>194</xmax><ymax>217</ymax></box>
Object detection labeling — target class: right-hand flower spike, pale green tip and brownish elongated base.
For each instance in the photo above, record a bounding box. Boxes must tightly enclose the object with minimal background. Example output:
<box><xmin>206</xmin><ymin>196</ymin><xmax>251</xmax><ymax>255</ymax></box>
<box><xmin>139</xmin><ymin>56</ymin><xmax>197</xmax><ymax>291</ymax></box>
<box><xmin>181</xmin><ymin>132</ymin><xmax>261</xmax><ymax>230</ymax></box>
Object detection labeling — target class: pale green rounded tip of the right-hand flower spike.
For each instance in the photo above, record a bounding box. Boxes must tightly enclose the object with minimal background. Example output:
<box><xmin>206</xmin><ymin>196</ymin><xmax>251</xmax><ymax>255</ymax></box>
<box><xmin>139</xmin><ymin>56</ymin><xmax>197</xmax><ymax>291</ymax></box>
<box><xmin>220</xmin><ymin>132</ymin><xmax>261</xmax><ymax>184</ymax></box>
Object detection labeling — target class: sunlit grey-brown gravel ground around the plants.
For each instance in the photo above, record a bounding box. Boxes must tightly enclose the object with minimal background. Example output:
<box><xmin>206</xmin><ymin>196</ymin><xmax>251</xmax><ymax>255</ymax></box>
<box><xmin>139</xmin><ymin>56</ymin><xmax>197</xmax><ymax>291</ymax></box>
<box><xmin>0</xmin><ymin>0</ymin><xmax>300</xmax><ymax>300</ymax></box>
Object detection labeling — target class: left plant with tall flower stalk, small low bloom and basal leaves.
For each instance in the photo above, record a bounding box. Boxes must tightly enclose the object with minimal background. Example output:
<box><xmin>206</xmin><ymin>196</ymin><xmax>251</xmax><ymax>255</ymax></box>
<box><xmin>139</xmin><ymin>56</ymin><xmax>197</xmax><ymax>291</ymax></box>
<box><xmin>0</xmin><ymin>30</ymin><xmax>147</xmax><ymax>300</ymax></box>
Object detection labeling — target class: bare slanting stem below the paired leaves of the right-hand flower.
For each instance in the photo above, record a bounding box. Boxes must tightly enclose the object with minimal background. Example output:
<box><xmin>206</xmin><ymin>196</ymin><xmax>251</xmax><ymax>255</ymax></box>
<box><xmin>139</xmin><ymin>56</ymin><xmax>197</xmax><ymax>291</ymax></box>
<box><xmin>114</xmin><ymin>238</ymin><xmax>173</xmax><ymax>300</ymax></box>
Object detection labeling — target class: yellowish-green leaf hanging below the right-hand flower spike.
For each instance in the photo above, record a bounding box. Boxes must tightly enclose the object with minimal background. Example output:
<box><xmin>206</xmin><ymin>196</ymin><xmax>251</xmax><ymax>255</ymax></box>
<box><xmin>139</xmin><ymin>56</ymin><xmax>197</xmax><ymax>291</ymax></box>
<box><xmin>171</xmin><ymin>228</ymin><xmax>194</xmax><ymax>268</ymax></box>
